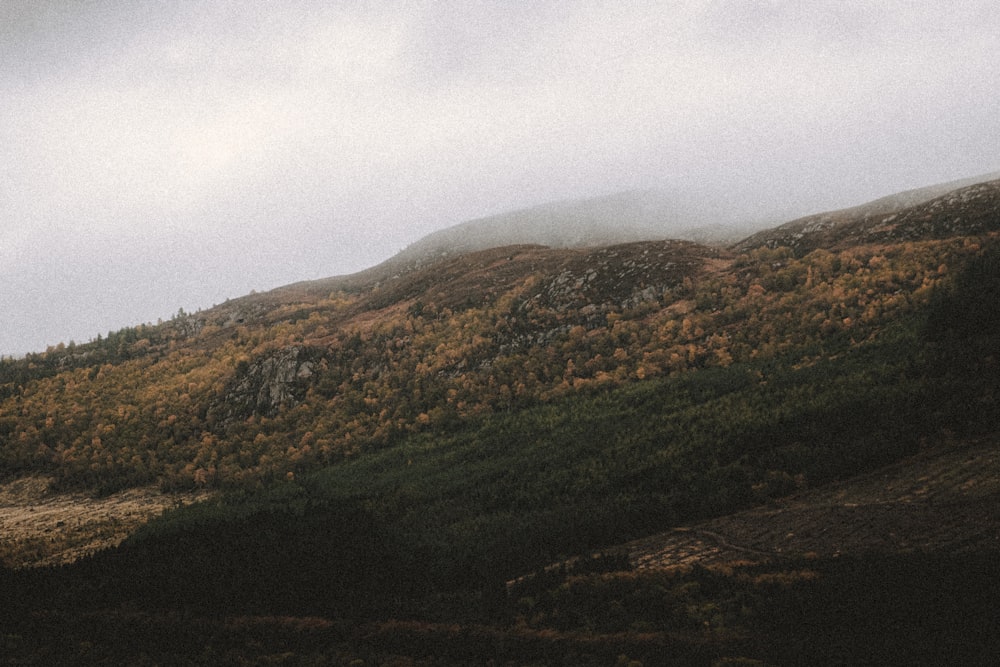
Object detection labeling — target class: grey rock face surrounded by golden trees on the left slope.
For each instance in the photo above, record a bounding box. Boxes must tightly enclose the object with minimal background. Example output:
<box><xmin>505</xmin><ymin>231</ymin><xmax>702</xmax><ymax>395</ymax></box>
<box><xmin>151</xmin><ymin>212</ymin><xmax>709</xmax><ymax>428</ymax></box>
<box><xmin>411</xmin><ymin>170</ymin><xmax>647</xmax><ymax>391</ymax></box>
<box><xmin>217</xmin><ymin>345</ymin><xmax>316</xmax><ymax>420</ymax></box>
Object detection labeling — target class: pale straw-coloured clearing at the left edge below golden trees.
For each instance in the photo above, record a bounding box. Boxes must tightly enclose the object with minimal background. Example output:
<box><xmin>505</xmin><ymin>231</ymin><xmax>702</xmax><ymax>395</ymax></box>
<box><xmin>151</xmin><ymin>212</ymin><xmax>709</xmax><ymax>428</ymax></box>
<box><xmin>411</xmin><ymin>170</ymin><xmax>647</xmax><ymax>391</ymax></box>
<box><xmin>0</xmin><ymin>477</ymin><xmax>209</xmax><ymax>567</ymax></box>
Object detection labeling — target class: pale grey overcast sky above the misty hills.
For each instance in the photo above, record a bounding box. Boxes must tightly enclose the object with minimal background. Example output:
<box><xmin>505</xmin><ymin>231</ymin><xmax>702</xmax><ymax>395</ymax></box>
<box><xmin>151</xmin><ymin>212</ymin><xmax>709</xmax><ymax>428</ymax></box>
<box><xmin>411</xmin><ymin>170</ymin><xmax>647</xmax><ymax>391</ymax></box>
<box><xmin>0</xmin><ymin>0</ymin><xmax>1000</xmax><ymax>356</ymax></box>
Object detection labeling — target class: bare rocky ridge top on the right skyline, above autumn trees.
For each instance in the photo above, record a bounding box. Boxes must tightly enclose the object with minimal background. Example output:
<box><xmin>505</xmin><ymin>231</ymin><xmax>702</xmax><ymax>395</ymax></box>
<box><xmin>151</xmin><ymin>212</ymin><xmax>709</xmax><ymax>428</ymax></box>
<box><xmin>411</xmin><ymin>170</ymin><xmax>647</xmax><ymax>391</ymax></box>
<box><xmin>735</xmin><ymin>172</ymin><xmax>1000</xmax><ymax>252</ymax></box>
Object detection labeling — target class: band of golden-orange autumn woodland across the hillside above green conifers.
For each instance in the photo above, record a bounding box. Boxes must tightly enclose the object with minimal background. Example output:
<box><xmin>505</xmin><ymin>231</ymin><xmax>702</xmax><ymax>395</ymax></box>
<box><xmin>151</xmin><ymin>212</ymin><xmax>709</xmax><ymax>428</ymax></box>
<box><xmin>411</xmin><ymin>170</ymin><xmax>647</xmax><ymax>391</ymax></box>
<box><xmin>0</xmin><ymin>237</ymin><xmax>982</xmax><ymax>493</ymax></box>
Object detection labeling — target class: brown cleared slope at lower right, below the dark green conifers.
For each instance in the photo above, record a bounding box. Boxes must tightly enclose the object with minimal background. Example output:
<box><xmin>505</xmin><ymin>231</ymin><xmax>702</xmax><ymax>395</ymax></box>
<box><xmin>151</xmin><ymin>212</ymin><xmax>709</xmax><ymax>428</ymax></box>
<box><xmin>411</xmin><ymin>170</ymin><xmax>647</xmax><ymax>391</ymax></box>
<box><xmin>623</xmin><ymin>436</ymin><xmax>1000</xmax><ymax>569</ymax></box>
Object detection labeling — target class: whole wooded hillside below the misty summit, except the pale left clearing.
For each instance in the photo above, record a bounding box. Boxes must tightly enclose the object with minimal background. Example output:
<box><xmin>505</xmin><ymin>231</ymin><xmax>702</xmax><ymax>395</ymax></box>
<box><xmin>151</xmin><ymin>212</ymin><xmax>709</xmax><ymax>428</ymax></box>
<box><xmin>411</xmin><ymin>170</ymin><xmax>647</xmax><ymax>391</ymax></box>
<box><xmin>0</xmin><ymin>174</ymin><xmax>1000</xmax><ymax>665</ymax></box>
